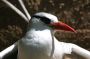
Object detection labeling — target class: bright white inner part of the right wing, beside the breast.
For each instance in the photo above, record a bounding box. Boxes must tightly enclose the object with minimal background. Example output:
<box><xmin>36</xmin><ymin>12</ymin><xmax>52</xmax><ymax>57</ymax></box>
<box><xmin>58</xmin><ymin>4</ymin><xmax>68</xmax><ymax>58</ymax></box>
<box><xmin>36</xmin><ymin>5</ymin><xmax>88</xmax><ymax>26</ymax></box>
<box><xmin>53</xmin><ymin>38</ymin><xmax>72</xmax><ymax>59</ymax></box>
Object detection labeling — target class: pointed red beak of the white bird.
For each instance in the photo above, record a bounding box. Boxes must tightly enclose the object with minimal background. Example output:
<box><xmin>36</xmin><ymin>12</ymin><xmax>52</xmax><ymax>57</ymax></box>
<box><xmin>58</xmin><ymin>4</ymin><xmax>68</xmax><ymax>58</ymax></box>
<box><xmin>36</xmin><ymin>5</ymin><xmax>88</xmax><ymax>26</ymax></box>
<box><xmin>51</xmin><ymin>22</ymin><xmax>76</xmax><ymax>33</ymax></box>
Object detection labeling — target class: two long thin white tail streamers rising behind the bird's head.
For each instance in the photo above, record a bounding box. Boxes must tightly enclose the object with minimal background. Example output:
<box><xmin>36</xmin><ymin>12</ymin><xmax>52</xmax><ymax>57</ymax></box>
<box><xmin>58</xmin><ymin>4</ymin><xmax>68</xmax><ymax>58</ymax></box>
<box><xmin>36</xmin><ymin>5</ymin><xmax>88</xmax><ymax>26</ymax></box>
<box><xmin>1</xmin><ymin>0</ymin><xmax>31</xmax><ymax>22</ymax></box>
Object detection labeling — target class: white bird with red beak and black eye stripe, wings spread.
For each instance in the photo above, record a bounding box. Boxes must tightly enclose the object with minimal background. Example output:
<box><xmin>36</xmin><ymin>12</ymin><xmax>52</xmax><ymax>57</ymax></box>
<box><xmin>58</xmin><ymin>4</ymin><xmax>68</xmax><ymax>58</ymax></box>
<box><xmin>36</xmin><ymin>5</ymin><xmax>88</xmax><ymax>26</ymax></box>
<box><xmin>0</xmin><ymin>0</ymin><xmax>90</xmax><ymax>59</ymax></box>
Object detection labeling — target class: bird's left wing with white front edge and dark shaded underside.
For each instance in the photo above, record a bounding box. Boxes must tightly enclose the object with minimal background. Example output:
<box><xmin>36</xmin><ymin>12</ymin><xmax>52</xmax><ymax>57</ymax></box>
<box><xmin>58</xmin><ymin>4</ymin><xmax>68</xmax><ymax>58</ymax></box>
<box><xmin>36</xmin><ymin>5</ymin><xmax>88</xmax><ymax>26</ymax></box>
<box><xmin>0</xmin><ymin>43</ymin><xmax>18</xmax><ymax>59</ymax></box>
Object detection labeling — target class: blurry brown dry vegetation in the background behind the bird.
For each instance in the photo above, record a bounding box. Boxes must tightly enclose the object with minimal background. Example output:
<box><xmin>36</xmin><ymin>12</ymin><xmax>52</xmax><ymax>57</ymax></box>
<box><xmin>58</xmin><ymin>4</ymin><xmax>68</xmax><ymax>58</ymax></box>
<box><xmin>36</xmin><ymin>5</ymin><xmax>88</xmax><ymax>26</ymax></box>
<box><xmin>0</xmin><ymin>0</ymin><xmax>90</xmax><ymax>59</ymax></box>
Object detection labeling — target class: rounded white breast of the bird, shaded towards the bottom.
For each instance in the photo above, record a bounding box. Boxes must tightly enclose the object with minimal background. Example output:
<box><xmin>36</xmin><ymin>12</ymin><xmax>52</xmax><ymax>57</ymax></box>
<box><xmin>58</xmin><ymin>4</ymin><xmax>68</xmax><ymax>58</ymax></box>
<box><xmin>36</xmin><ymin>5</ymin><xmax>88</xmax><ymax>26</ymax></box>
<box><xmin>18</xmin><ymin>31</ymin><xmax>52</xmax><ymax>59</ymax></box>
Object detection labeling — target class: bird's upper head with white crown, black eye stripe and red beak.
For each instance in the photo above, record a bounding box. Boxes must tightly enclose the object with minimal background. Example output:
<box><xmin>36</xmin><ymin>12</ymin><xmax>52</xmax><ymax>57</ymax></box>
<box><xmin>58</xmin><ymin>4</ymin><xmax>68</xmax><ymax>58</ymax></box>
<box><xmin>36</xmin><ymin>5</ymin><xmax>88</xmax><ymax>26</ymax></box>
<box><xmin>32</xmin><ymin>12</ymin><xmax>76</xmax><ymax>32</ymax></box>
